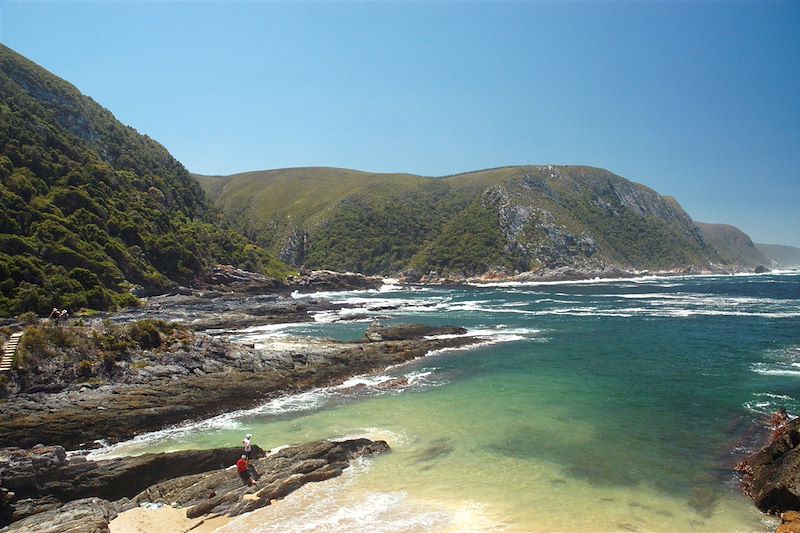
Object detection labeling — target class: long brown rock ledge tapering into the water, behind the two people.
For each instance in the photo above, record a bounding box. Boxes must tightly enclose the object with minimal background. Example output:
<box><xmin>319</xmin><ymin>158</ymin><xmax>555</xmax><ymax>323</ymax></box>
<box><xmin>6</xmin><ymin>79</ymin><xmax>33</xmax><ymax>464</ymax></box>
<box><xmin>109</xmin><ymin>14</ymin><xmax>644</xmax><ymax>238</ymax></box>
<box><xmin>0</xmin><ymin>326</ymin><xmax>476</xmax><ymax>449</ymax></box>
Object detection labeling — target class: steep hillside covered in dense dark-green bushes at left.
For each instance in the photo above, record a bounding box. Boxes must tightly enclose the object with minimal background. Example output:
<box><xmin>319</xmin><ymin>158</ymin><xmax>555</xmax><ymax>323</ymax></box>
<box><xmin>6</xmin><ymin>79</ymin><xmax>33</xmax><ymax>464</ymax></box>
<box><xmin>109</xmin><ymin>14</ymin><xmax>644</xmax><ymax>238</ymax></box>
<box><xmin>0</xmin><ymin>45</ymin><xmax>287</xmax><ymax>316</ymax></box>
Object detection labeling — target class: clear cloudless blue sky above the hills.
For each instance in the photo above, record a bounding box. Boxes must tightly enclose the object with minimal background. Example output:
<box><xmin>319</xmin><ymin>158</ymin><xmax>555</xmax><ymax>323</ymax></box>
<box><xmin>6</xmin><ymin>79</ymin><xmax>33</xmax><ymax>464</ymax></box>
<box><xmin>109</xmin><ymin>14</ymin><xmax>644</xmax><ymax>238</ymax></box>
<box><xmin>0</xmin><ymin>0</ymin><xmax>800</xmax><ymax>246</ymax></box>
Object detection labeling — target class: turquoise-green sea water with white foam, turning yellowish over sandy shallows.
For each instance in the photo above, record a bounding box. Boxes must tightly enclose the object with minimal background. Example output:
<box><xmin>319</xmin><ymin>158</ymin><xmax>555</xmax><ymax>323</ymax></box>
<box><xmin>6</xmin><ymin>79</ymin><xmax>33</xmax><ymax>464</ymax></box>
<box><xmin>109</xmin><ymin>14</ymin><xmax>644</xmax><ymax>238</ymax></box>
<box><xmin>103</xmin><ymin>274</ymin><xmax>800</xmax><ymax>531</ymax></box>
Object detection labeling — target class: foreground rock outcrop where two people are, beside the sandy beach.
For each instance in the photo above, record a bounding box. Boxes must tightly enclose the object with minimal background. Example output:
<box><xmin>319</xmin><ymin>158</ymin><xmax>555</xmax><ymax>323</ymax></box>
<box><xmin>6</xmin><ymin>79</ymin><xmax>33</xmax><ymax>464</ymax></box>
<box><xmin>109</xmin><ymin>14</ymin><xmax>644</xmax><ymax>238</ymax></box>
<box><xmin>0</xmin><ymin>439</ymin><xmax>389</xmax><ymax>533</ymax></box>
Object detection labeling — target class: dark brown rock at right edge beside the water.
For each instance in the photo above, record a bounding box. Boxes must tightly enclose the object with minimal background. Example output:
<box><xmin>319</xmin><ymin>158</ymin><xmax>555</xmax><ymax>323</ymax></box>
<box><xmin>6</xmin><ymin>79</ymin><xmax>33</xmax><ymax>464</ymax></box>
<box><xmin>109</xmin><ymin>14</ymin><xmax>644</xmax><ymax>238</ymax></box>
<box><xmin>737</xmin><ymin>418</ymin><xmax>800</xmax><ymax>514</ymax></box>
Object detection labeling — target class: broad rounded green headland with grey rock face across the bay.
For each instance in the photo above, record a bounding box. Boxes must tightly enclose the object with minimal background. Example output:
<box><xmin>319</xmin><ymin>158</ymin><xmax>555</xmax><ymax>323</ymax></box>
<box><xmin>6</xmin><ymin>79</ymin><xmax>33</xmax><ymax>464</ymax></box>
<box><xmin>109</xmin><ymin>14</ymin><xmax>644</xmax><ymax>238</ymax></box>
<box><xmin>196</xmin><ymin>165</ymin><xmax>723</xmax><ymax>276</ymax></box>
